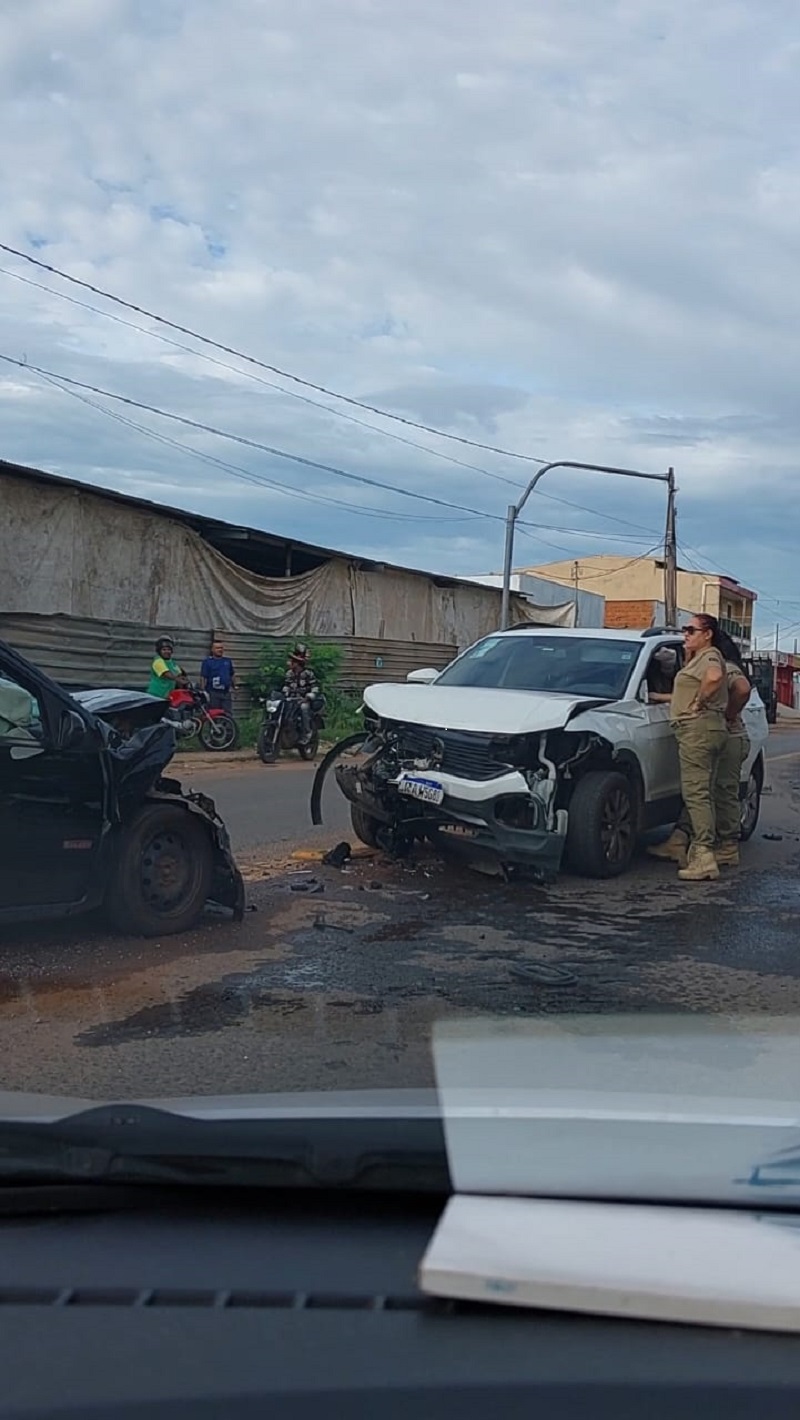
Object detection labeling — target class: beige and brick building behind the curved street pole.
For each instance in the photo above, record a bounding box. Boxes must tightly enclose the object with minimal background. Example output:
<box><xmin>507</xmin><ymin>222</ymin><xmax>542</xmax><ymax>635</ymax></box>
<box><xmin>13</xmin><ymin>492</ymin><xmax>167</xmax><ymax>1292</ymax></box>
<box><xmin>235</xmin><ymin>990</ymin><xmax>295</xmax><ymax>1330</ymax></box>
<box><xmin>520</xmin><ymin>554</ymin><xmax>757</xmax><ymax>650</ymax></box>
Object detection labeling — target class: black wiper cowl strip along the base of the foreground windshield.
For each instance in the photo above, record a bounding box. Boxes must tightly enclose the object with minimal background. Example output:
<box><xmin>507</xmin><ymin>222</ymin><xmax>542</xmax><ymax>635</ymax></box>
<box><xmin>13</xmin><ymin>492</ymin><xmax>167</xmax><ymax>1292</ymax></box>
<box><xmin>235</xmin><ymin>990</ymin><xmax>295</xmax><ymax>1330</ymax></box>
<box><xmin>0</xmin><ymin>1105</ymin><xmax>450</xmax><ymax>1194</ymax></box>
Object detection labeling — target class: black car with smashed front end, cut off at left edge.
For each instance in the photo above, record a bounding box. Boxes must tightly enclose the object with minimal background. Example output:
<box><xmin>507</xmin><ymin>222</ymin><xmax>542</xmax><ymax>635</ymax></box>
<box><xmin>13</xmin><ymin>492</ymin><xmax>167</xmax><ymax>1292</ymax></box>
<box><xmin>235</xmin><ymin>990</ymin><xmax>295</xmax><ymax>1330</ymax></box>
<box><xmin>0</xmin><ymin>642</ymin><xmax>244</xmax><ymax>936</ymax></box>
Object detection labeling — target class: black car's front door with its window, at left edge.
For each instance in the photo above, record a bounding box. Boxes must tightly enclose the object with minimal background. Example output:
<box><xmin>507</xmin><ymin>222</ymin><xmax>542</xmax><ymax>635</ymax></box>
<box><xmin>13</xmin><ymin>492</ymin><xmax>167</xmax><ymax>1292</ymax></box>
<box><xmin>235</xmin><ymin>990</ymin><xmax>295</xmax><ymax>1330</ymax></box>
<box><xmin>0</xmin><ymin>649</ymin><xmax>108</xmax><ymax>919</ymax></box>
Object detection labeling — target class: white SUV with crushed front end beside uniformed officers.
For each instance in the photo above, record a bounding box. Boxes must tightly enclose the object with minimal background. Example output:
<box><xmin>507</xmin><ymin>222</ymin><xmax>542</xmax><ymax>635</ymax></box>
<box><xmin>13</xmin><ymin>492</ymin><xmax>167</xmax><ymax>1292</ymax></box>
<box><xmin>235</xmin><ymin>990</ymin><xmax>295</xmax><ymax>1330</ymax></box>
<box><xmin>329</xmin><ymin>628</ymin><xmax>769</xmax><ymax>879</ymax></box>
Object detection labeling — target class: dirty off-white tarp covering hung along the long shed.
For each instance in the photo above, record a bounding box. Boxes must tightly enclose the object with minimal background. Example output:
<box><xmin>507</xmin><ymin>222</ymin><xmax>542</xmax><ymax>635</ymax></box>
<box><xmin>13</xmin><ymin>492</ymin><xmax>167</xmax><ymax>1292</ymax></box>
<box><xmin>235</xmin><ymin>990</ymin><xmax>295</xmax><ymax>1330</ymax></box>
<box><xmin>0</xmin><ymin>474</ymin><xmax>574</xmax><ymax>646</ymax></box>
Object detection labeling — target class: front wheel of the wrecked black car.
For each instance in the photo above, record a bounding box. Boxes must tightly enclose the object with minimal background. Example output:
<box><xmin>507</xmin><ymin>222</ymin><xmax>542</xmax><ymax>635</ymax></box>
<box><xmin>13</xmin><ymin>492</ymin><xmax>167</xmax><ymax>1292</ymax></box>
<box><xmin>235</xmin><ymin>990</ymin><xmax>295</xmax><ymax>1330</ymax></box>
<box><xmin>105</xmin><ymin>804</ymin><xmax>215</xmax><ymax>937</ymax></box>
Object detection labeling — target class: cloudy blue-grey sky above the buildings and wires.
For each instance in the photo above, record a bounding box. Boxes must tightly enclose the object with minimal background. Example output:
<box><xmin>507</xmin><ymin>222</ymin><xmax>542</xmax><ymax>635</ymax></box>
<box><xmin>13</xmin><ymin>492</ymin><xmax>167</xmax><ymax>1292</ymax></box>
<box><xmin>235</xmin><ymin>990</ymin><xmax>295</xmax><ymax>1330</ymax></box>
<box><xmin>0</xmin><ymin>0</ymin><xmax>800</xmax><ymax>645</ymax></box>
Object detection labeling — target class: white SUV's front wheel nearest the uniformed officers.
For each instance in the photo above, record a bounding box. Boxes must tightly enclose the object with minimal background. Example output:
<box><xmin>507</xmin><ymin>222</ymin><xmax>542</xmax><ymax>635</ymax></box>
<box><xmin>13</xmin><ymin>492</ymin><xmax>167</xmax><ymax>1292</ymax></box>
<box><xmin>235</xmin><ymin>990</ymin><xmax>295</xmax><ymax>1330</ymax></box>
<box><xmin>567</xmin><ymin>770</ymin><xmax>637</xmax><ymax>878</ymax></box>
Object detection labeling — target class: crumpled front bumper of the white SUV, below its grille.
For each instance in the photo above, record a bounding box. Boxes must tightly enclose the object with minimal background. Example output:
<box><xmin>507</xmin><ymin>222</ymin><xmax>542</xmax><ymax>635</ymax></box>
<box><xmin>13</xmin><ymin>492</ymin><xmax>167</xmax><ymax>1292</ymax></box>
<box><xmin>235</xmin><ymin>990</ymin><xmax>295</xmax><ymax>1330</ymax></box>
<box><xmin>335</xmin><ymin>764</ymin><xmax>567</xmax><ymax>879</ymax></box>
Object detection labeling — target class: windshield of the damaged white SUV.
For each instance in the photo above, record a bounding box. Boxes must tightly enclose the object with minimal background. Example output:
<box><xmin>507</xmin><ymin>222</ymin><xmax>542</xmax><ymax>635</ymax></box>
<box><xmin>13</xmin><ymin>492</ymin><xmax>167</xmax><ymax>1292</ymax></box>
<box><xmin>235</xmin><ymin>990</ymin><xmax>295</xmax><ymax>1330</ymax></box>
<box><xmin>436</xmin><ymin>633</ymin><xmax>641</xmax><ymax>700</ymax></box>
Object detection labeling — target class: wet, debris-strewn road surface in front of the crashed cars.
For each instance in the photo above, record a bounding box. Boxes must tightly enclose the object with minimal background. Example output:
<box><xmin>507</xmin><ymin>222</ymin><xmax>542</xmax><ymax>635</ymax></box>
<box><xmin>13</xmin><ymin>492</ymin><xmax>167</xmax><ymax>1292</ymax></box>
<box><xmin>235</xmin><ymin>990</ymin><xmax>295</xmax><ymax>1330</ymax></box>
<box><xmin>0</xmin><ymin>731</ymin><xmax>800</xmax><ymax>1098</ymax></box>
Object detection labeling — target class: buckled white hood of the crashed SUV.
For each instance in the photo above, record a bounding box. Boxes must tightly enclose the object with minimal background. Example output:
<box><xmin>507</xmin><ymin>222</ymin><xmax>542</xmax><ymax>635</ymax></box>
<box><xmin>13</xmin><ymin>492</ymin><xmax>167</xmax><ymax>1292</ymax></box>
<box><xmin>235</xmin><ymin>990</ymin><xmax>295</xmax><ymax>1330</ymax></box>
<box><xmin>364</xmin><ymin>684</ymin><xmax>608</xmax><ymax>734</ymax></box>
